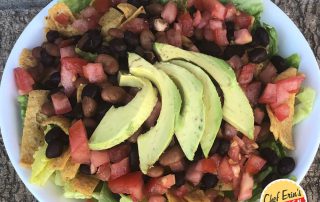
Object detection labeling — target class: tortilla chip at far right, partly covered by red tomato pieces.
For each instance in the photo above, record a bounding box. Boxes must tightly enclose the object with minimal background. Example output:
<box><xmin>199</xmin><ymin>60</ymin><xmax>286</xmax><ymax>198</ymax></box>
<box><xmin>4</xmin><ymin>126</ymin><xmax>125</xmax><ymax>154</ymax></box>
<box><xmin>267</xmin><ymin>68</ymin><xmax>297</xmax><ymax>149</ymax></box>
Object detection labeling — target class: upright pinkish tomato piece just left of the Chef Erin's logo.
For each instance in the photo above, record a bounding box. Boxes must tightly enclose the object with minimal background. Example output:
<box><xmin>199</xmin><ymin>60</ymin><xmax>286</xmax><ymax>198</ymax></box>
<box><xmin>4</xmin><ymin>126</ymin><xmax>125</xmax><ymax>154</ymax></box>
<box><xmin>238</xmin><ymin>172</ymin><xmax>254</xmax><ymax>201</ymax></box>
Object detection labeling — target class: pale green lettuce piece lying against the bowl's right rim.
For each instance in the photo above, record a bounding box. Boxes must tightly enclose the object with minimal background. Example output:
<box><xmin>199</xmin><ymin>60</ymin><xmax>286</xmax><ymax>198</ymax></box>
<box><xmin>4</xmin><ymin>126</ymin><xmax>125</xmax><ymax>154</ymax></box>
<box><xmin>293</xmin><ymin>87</ymin><xmax>316</xmax><ymax>124</ymax></box>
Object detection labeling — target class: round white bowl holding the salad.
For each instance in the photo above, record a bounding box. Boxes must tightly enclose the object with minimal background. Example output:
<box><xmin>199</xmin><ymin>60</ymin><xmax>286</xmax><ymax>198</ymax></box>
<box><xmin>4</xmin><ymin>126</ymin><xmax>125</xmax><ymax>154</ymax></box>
<box><xmin>0</xmin><ymin>0</ymin><xmax>320</xmax><ymax>202</ymax></box>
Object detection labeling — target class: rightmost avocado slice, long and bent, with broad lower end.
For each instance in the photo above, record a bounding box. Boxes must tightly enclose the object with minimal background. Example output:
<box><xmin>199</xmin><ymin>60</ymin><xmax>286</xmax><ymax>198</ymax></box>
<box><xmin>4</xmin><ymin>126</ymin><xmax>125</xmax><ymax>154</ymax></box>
<box><xmin>154</xmin><ymin>43</ymin><xmax>254</xmax><ymax>139</ymax></box>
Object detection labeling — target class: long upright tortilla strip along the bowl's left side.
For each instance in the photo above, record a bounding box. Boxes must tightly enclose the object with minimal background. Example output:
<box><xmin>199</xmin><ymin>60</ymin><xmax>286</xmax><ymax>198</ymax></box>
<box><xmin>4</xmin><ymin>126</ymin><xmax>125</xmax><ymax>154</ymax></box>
<box><xmin>20</xmin><ymin>90</ymin><xmax>49</xmax><ymax>168</ymax></box>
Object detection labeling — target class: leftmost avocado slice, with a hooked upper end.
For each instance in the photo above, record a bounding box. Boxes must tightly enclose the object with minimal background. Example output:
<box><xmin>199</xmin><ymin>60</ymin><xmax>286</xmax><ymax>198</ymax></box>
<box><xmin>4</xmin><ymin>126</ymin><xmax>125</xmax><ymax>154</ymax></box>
<box><xmin>89</xmin><ymin>73</ymin><xmax>157</xmax><ymax>150</ymax></box>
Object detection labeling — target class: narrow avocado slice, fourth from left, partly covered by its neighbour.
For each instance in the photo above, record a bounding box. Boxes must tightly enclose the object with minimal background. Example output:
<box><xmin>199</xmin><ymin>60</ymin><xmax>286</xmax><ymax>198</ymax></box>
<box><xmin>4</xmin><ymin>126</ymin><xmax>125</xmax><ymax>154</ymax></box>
<box><xmin>170</xmin><ymin>60</ymin><xmax>222</xmax><ymax>157</ymax></box>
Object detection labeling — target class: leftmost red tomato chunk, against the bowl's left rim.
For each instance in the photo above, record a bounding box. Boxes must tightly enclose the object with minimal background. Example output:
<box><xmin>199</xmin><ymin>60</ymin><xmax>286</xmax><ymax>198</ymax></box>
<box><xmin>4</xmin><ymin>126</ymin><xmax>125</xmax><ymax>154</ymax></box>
<box><xmin>13</xmin><ymin>67</ymin><xmax>35</xmax><ymax>95</ymax></box>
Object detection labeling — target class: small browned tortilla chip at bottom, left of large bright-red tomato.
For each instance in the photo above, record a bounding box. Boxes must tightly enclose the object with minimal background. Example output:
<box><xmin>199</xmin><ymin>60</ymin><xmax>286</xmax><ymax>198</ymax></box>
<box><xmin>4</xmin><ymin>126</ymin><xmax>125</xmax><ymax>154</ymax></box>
<box><xmin>69</xmin><ymin>174</ymin><xmax>100</xmax><ymax>196</ymax></box>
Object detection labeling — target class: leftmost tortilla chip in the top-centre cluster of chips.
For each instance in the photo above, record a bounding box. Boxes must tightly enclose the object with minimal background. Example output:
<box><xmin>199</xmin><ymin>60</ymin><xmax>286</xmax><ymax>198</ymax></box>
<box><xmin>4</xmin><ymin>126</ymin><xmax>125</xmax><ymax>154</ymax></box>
<box><xmin>99</xmin><ymin>8</ymin><xmax>124</xmax><ymax>37</ymax></box>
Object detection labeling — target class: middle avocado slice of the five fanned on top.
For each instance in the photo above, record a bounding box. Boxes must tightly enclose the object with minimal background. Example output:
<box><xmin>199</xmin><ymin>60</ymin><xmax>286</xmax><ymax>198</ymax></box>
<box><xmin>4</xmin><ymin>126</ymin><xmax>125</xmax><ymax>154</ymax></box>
<box><xmin>155</xmin><ymin>62</ymin><xmax>205</xmax><ymax>160</ymax></box>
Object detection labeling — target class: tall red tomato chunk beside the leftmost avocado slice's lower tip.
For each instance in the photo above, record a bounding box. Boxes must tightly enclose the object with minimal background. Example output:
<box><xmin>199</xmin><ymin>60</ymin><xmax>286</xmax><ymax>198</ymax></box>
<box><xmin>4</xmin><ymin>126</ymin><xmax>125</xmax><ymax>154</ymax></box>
<box><xmin>69</xmin><ymin>120</ymin><xmax>90</xmax><ymax>164</ymax></box>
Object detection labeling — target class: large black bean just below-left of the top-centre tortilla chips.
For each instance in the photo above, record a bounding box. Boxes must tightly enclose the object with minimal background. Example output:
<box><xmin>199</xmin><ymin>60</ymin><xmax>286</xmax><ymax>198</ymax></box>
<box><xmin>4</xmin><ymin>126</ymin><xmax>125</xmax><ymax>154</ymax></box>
<box><xmin>77</xmin><ymin>30</ymin><xmax>102</xmax><ymax>52</ymax></box>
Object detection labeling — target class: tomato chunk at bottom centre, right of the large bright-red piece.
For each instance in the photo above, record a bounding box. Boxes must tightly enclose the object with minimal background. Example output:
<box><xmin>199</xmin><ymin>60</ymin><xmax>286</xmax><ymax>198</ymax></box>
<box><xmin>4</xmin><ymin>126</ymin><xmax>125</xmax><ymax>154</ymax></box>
<box><xmin>146</xmin><ymin>174</ymin><xmax>176</xmax><ymax>196</ymax></box>
